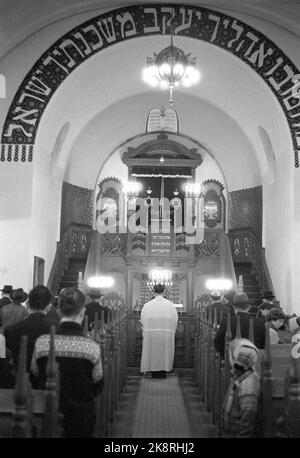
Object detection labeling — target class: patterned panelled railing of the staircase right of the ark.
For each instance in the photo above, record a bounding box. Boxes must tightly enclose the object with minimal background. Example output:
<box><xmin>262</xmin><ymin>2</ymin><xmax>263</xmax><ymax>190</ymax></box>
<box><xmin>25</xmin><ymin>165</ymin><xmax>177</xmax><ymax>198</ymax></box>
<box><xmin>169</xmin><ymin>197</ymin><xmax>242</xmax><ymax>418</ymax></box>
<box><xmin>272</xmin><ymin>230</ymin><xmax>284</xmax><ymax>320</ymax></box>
<box><xmin>228</xmin><ymin>228</ymin><xmax>274</xmax><ymax>292</ymax></box>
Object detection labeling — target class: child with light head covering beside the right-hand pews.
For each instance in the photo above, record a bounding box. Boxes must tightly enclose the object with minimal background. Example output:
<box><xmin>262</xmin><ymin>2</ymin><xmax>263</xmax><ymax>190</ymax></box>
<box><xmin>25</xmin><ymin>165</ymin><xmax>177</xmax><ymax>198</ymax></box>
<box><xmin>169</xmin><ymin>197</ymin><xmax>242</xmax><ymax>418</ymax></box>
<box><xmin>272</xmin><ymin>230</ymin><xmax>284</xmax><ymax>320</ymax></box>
<box><xmin>223</xmin><ymin>339</ymin><xmax>259</xmax><ymax>438</ymax></box>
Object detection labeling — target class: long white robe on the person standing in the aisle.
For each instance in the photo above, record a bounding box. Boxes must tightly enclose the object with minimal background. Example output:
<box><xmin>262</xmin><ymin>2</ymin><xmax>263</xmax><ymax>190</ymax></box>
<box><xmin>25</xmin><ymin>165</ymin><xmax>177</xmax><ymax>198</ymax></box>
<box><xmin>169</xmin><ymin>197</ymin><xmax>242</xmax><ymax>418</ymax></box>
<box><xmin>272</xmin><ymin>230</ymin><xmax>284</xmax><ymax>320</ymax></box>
<box><xmin>141</xmin><ymin>296</ymin><xmax>178</xmax><ymax>372</ymax></box>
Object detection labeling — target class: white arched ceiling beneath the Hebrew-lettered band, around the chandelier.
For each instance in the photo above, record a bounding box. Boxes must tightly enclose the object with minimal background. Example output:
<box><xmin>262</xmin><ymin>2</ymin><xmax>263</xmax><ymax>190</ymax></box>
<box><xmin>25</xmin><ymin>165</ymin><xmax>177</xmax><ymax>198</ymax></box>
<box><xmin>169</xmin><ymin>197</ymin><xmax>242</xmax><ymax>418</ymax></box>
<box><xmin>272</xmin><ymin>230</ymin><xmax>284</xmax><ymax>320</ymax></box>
<box><xmin>35</xmin><ymin>36</ymin><xmax>293</xmax><ymax>189</ymax></box>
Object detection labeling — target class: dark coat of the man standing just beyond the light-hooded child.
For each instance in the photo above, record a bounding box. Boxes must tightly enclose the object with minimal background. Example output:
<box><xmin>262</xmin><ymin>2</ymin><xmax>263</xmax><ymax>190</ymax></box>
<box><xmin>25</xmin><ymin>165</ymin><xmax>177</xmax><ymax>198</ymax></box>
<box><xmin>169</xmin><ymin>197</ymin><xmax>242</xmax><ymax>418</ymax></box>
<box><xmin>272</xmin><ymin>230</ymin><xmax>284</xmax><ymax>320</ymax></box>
<box><xmin>214</xmin><ymin>312</ymin><xmax>266</xmax><ymax>359</ymax></box>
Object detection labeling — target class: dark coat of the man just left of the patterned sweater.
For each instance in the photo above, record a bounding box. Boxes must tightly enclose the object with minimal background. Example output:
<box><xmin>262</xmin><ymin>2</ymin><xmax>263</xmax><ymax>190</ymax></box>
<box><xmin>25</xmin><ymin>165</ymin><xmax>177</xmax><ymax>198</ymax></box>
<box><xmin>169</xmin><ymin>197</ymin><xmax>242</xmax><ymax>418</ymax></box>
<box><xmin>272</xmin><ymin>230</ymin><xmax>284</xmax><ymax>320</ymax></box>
<box><xmin>4</xmin><ymin>312</ymin><xmax>54</xmax><ymax>371</ymax></box>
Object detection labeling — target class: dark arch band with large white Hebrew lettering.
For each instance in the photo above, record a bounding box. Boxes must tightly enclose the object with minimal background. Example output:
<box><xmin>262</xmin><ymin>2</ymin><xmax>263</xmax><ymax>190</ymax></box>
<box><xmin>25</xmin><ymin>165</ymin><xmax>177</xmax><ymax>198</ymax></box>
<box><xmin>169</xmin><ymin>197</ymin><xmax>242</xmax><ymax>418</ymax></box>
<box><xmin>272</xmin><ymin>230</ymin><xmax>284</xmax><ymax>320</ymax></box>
<box><xmin>0</xmin><ymin>3</ymin><xmax>300</xmax><ymax>167</ymax></box>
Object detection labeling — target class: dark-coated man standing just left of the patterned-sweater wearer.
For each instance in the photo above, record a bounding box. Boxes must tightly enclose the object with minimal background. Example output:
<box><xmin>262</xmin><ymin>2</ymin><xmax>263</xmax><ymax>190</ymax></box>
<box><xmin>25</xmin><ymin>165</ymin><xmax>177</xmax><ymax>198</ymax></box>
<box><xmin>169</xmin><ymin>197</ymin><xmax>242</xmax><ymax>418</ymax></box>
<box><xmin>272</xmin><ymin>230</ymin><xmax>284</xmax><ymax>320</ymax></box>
<box><xmin>4</xmin><ymin>285</ymin><xmax>54</xmax><ymax>371</ymax></box>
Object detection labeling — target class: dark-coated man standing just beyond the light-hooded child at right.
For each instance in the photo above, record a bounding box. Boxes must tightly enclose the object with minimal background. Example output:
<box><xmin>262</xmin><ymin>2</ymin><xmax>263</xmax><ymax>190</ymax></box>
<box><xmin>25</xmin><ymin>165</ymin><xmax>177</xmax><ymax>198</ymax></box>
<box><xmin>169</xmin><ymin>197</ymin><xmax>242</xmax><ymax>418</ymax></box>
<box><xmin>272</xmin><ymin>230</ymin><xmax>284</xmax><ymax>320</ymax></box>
<box><xmin>214</xmin><ymin>293</ymin><xmax>265</xmax><ymax>359</ymax></box>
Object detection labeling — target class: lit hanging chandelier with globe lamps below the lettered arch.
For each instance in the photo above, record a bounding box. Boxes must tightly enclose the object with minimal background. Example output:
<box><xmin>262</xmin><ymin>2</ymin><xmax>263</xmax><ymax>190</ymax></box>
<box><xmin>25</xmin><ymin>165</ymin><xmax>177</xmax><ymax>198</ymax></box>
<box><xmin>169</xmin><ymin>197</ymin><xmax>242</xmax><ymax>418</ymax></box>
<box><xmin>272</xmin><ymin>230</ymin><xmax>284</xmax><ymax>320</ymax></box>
<box><xmin>143</xmin><ymin>31</ymin><xmax>200</xmax><ymax>105</ymax></box>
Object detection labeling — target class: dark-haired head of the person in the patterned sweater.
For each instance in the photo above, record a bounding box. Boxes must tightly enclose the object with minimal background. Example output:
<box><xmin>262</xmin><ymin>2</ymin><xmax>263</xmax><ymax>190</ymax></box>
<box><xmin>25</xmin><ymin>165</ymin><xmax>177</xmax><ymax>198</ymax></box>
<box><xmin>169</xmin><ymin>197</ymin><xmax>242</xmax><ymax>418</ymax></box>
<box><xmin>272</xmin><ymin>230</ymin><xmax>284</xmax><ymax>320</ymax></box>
<box><xmin>58</xmin><ymin>288</ymin><xmax>86</xmax><ymax>324</ymax></box>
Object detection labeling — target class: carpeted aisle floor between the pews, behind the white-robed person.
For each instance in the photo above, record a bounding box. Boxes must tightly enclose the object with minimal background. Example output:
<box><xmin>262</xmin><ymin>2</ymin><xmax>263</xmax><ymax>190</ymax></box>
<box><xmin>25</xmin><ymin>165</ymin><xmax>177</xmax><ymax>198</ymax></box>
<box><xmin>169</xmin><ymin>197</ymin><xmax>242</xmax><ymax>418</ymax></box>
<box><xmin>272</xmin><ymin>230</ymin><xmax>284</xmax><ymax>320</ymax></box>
<box><xmin>109</xmin><ymin>370</ymin><xmax>216</xmax><ymax>438</ymax></box>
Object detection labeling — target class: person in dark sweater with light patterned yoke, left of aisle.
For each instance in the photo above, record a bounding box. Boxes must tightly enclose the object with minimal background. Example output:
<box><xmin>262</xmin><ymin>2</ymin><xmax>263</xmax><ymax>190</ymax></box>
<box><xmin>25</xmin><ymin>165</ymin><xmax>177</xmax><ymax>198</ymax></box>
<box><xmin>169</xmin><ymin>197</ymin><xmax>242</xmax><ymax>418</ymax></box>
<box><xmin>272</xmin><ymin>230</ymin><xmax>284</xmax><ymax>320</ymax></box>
<box><xmin>31</xmin><ymin>288</ymin><xmax>103</xmax><ymax>438</ymax></box>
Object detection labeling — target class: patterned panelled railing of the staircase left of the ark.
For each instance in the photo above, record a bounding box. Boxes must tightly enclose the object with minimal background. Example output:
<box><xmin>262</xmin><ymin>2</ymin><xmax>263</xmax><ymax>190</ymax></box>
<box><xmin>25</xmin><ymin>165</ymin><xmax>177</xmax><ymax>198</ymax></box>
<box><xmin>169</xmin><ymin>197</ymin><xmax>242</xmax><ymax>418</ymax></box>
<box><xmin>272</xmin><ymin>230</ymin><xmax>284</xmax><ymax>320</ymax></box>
<box><xmin>47</xmin><ymin>223</ymin><xmax>91</xmax><ymax>293</ymax></box>
